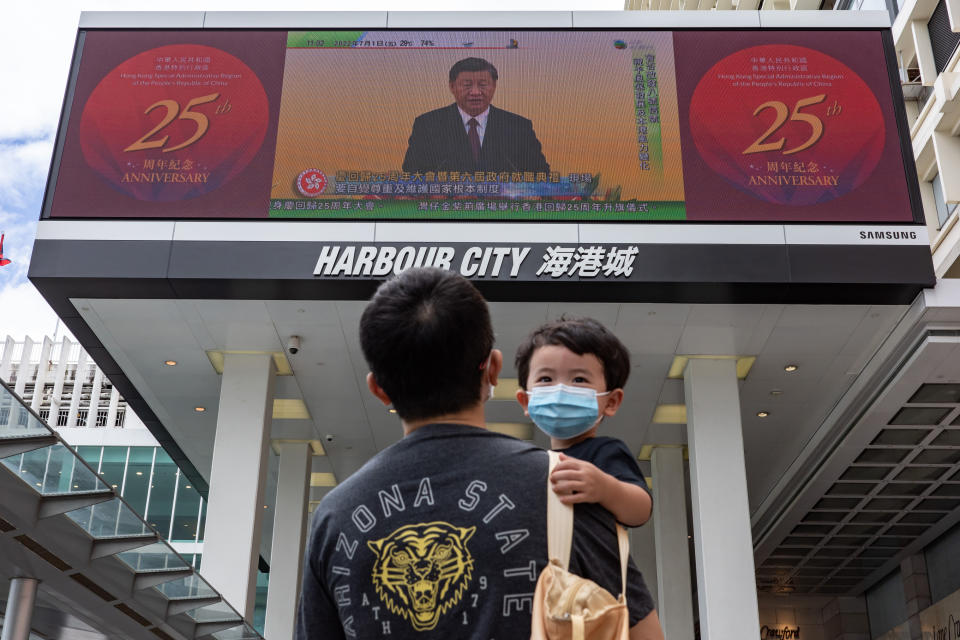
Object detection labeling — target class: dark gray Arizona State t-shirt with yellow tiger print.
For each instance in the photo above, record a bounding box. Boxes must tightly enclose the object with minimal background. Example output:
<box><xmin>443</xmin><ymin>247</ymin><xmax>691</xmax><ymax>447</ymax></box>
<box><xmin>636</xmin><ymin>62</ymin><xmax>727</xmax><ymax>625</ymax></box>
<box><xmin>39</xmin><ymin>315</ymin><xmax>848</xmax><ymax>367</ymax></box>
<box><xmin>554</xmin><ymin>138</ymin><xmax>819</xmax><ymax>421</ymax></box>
<box><xmin>296</xmin><ymin>424</ymin><xmax>640</xmax><ymax>640</ymax></box>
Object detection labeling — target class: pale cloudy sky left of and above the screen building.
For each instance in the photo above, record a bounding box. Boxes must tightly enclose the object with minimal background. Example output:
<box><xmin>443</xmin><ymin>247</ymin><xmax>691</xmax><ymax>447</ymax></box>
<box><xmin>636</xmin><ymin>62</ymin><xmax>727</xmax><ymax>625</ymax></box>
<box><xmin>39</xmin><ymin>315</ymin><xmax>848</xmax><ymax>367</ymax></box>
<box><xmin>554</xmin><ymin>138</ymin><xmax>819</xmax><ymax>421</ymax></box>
<box><xmin>0</xmin><ymin>0</ymin><xmax>623</xmax><ymax>340</ymax></box>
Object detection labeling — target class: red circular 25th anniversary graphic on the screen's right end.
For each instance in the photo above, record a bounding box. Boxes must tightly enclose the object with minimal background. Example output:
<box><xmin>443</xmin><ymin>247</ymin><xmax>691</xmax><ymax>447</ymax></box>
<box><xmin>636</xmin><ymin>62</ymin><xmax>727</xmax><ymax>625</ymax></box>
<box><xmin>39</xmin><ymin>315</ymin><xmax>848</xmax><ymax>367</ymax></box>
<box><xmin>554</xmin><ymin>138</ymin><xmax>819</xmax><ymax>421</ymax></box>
<box><xmin>690</xmin><ymin>44</ymin><xmax>886</xmax><ymax>205</ymax></box>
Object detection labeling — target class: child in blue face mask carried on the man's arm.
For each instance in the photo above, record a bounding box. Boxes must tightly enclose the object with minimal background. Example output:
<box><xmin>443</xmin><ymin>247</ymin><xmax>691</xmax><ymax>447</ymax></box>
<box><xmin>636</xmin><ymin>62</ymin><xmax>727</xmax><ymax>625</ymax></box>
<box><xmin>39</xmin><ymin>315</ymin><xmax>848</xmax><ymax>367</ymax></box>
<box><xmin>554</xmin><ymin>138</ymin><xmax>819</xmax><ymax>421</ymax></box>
<box><xmin>516</xmin><ymin>318</ymin><xmax>663</xmax><ymax>640</ymax></box>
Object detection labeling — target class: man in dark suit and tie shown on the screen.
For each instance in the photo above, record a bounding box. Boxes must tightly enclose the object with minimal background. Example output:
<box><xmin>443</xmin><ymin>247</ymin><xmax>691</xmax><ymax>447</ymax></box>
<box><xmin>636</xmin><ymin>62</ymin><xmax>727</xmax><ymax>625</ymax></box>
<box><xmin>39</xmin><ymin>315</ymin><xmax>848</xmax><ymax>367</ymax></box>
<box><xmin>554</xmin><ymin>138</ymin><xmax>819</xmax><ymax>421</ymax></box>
<box><xmin>403</xmin><ymin>58</ymin><xmax>550</xmax><ymax>173</ymax></box>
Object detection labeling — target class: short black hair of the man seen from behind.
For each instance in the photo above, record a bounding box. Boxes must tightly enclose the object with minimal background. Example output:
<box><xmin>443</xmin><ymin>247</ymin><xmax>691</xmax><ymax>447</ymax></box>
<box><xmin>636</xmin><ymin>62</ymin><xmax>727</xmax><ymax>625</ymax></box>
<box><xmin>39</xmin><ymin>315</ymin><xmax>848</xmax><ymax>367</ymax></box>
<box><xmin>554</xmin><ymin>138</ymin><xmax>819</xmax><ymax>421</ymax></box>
<box><xmin>360</xmin><ymin>268</ymin><xmax>493</xmax><ymax>420</ymax></box>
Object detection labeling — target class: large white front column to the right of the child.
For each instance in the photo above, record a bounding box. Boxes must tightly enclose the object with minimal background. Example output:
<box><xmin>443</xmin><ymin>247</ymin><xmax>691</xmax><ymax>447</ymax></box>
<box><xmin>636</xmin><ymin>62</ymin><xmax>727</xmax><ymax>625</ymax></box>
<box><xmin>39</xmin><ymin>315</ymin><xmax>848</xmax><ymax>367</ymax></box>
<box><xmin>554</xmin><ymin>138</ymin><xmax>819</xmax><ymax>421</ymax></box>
<box><xmin>683</xmin><ymin>358</ymin><xmax>760</xmax><ymax>640</ymax></box>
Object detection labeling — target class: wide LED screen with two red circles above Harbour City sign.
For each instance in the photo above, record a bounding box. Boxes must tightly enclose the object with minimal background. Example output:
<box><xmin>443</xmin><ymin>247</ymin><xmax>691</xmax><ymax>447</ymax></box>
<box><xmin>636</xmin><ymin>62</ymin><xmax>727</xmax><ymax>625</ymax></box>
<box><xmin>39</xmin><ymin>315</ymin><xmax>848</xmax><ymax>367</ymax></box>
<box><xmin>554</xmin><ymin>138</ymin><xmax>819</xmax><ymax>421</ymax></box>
<box><xmin>49</xmin><ymin>30</ymin><xmax>914</xmax><ymax>222</ymax></box>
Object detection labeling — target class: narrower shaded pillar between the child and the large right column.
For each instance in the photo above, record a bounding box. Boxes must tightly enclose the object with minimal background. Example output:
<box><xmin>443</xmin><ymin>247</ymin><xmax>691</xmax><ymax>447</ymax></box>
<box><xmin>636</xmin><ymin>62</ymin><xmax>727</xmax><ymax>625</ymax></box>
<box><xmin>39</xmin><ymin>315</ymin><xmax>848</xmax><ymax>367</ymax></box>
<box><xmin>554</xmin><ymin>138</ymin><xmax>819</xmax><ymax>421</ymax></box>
<box><xmin>650</xmin><ymin>447</ymin><xmax>693</xmax><ymax>640</ymax></box>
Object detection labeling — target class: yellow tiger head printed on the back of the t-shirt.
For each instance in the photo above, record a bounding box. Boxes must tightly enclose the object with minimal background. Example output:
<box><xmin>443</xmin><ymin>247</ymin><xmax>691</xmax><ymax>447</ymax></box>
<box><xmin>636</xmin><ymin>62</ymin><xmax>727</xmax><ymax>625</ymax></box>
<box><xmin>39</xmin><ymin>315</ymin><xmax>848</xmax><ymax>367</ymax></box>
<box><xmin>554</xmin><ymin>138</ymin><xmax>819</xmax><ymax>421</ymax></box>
<box><xmin>367</xmin><ymin>522</ymin><xmax>477</xmax><ymax>631</ymax></box>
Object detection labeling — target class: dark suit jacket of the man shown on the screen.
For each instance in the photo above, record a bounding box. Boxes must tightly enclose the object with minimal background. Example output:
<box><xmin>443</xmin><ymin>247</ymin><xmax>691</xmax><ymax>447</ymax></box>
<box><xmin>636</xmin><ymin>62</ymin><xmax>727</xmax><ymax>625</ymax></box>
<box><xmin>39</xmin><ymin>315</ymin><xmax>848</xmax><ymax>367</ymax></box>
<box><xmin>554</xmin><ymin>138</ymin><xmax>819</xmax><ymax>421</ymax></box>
<box><xmin>403</xmin><ymin>103</ymin><xmax>550</xmax><ymax>173</ymax></box>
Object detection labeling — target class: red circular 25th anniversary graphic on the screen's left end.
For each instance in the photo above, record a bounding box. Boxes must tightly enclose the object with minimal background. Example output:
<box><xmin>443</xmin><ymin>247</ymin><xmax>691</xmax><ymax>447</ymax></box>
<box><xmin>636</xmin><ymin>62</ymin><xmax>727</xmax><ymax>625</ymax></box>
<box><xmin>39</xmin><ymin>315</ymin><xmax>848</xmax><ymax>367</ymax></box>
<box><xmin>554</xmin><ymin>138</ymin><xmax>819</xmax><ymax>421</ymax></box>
<box><xmin>80</xmin><ymin>44</ymin><xmax>269</xmax><ymax>202</ymax></box>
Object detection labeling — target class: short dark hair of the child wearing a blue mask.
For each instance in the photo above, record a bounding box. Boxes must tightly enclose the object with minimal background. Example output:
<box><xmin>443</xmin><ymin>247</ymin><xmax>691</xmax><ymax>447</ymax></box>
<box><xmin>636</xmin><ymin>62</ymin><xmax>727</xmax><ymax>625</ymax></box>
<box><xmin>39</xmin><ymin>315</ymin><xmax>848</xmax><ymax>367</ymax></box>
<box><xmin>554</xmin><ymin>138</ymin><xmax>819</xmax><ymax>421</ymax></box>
<box><xmin>514</xmin><ymin>316</ymin><xmax>630</xmax><ymax>390</ymax></box>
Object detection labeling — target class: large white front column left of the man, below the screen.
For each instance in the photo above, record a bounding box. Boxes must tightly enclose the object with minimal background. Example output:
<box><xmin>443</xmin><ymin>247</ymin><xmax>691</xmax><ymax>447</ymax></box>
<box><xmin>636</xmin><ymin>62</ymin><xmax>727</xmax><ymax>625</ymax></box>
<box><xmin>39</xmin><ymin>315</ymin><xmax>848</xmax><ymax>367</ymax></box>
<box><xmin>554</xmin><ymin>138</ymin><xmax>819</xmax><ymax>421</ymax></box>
<box><xmin>200</xmin><ymin>353</ymin><xmax>274</xmax><ymax>621</ymax></box>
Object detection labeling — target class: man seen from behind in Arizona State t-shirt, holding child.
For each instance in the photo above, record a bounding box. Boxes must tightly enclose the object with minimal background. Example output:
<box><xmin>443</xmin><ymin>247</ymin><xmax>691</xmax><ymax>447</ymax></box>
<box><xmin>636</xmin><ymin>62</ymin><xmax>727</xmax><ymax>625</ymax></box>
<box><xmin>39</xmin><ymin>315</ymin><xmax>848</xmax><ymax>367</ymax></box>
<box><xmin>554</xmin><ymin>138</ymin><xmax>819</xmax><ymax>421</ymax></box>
<box><xmin>296</xmin><ymin>268</ymin><xmax>652</xmax><ymax>640</ymax></box>
